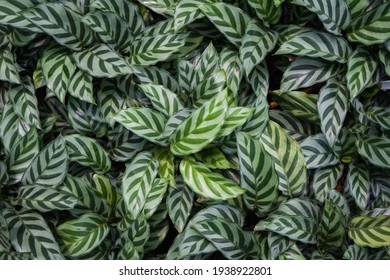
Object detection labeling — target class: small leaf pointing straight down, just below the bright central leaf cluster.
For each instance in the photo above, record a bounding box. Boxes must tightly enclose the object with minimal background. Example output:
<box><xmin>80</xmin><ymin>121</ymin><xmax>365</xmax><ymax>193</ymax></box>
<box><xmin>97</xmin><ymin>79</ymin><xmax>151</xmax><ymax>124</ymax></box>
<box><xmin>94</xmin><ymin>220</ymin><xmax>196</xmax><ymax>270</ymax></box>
<box><xmin>167</xmin><ymin>184</ymin><xmax>194</xmax><ymax>233</ymax></box>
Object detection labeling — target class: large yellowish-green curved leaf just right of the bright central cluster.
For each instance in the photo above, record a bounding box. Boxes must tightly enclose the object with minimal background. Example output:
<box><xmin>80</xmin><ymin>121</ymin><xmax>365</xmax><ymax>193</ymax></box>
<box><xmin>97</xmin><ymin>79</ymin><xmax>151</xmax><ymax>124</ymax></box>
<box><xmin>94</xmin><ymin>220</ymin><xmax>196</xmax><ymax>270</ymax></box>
<box><xmin>260</xmin><ymin>121</ymin><xmax>307</xmax><ymax>196</ymax></box>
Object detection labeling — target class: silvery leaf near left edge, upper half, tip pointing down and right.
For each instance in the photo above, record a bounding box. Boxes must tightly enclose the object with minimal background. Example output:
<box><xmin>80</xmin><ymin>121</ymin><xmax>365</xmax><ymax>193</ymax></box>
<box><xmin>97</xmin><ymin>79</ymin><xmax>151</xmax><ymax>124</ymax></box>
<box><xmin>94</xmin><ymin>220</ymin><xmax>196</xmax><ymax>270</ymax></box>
<box><xmin>8</xmin><ymin>76</ymin><xmax>41</xmax><ymax>128</ymax></box>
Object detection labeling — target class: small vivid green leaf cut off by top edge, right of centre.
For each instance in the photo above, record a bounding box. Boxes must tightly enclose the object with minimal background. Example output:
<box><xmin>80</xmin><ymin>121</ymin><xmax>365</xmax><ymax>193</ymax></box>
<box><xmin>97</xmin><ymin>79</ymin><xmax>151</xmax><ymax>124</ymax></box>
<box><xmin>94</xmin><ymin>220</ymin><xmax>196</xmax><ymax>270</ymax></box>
<box><xmin>248</xmin><ymin>0</ymin><xmax>282</xmax><ymax>26</ymax></box>
